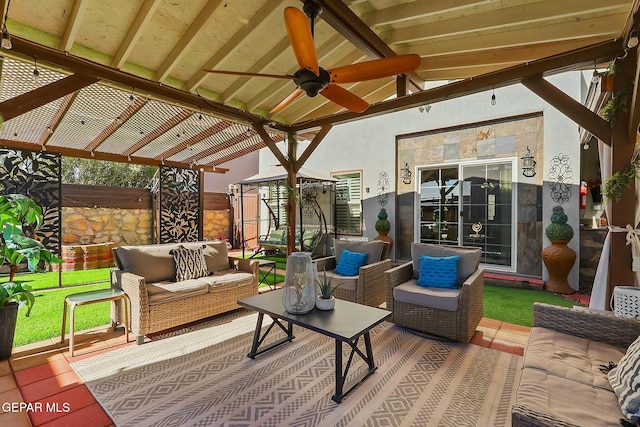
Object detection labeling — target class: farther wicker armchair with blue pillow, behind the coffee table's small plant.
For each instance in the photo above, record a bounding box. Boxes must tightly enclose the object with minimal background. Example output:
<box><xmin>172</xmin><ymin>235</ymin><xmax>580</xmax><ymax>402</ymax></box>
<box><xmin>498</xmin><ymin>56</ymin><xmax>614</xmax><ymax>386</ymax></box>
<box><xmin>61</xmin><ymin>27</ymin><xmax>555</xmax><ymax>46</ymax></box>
<box><xmin>316</xmin><ymin>240</ymin><xmax>391</xmax><ymax>307</ymax></box>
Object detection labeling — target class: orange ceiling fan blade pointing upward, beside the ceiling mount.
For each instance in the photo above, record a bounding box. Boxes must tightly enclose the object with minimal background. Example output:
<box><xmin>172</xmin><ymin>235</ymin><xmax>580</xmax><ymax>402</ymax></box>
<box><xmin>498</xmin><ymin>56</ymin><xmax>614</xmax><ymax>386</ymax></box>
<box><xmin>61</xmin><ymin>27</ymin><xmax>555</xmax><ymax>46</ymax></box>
<box><xmin>284</xmin><ymin>7</ymin><xmax>320</xmax><ymax>76</ymax></box>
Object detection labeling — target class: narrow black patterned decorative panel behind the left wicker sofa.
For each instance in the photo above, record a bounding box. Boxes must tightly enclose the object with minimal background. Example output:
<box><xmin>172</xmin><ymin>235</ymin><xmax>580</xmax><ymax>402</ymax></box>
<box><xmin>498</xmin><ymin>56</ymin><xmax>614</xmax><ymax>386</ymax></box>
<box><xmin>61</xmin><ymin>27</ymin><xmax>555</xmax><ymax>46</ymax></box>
<box><xmin>159</xmin><ymin>166</ymin><xmax>200</xmax><ymax>243</ymax></box>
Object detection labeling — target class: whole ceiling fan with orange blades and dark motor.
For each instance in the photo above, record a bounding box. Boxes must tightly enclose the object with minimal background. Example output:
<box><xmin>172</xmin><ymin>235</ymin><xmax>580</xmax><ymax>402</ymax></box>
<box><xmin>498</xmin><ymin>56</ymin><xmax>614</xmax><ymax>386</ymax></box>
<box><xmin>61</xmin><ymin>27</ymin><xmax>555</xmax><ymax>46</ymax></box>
<box><xmin>205</xmin><ymin>2</ymin><xmax>420</xmax><ymax>113</ymax></box>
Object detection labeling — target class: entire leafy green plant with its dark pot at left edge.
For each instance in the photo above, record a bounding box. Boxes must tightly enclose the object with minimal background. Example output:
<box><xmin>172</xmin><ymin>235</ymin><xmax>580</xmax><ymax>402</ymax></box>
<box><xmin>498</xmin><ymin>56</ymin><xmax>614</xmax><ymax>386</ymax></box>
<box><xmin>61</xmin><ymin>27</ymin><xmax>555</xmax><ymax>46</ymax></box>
<box><xmin>0</xmin><ymin>194</ymin><xmax>62</xmax><ymax>360</ymax></box>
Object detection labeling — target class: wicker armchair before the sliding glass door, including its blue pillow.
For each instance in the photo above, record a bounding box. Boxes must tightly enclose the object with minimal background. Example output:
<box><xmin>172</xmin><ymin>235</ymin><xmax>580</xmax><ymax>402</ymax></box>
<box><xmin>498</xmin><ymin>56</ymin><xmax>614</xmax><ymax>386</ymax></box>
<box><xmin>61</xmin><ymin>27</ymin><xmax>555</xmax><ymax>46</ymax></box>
<box><xmin>385</xmin><ymin>243</ymin><xmax>484</xmax><ymax>342</ymax></box>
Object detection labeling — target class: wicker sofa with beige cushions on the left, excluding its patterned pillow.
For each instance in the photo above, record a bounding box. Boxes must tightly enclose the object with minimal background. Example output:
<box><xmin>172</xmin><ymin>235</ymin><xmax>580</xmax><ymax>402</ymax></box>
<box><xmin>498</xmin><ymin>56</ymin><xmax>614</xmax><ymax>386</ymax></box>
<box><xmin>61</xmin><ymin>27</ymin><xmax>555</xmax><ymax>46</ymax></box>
<box><xmin>111</xmin><ymin>240</ymin><xmax>258</xmax><ymax>344</ymax></box>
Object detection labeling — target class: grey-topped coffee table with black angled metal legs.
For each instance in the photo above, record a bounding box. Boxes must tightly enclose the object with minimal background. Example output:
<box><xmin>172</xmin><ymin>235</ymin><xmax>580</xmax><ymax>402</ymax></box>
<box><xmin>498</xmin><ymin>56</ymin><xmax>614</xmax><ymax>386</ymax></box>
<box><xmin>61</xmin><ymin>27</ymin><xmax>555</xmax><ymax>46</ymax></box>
<box><xmin>238</xmin><ymin>289</ymin><xmax>391</xmax><ymax>403</ymax></box>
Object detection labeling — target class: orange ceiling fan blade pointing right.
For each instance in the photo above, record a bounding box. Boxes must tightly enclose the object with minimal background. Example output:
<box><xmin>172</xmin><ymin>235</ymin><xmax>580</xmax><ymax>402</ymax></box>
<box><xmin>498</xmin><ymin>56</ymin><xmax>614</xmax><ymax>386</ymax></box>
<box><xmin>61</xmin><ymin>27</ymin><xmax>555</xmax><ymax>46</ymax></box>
<box><xmin>329</xmin><ymin>54</ymin><xmax>420</xmax><ymax>83</ymax></box>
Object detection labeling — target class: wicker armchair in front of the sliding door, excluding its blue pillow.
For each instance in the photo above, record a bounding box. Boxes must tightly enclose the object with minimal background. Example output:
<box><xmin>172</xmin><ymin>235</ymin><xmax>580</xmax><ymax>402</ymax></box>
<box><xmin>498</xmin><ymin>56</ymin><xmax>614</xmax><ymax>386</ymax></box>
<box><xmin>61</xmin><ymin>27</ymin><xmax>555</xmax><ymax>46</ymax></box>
<box><xmin>385</xmin><ymin>243</ymin><xmax>484</xmax><ymax>342</ymax></box>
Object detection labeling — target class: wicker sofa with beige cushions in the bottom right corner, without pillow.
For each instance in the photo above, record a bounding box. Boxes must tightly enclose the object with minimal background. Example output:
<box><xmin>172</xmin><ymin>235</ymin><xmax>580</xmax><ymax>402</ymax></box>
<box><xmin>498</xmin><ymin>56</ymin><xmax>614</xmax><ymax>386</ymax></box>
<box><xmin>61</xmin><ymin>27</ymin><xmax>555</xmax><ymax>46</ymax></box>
<box><xmin>511</xmin><ymin>303</ymin><xmax>640</xmax><ymax>427</ymax></box>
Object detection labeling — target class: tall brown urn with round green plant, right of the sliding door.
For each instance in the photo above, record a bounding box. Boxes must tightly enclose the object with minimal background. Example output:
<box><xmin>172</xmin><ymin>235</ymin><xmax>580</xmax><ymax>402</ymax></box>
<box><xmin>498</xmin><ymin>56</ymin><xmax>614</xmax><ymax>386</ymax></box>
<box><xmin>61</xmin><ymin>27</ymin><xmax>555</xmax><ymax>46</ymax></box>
<box><xmin>542</xmin><ymin>206</ymin><xmax>576</xmax><ymax>294</ymax></box>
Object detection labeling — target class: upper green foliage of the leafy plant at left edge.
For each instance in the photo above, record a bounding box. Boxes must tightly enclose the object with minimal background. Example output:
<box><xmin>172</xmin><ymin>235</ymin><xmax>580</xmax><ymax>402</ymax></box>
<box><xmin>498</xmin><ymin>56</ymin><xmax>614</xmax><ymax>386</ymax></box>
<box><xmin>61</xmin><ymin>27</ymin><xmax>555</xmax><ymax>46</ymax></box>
<box><xmin>0</xmin><ymin>194</ymin><xmax>62</xmax><ymax>282</ymax></box>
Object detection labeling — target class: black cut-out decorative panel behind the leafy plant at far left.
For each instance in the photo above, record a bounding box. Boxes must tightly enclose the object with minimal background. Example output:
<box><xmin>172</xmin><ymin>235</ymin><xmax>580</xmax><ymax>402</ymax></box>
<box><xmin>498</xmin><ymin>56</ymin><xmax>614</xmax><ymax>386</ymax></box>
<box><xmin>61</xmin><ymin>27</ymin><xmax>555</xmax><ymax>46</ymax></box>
<box><xmin>0</xmin><ymin>147</ymin><xmax>62</xmax><ymax>255</ymax></box>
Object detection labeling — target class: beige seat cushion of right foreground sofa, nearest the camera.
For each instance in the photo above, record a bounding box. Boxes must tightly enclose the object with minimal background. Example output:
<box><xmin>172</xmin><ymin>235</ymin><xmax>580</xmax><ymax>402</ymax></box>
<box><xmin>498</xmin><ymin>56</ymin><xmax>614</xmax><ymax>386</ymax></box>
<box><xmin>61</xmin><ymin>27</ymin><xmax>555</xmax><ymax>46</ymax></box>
<box><xmin>516</xmin><ymin>368</ymin><xmax>622</xmax><ymax>427</ymax></box>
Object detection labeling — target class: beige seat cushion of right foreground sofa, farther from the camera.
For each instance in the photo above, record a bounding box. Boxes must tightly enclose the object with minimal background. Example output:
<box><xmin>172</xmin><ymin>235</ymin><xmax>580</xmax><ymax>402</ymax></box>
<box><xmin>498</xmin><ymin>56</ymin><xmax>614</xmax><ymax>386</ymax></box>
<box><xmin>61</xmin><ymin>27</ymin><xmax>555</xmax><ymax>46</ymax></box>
<box><xmin>523</xmin><ymin>328</ymin><xmax>625</xmax><ymax>390</ymax></box>
